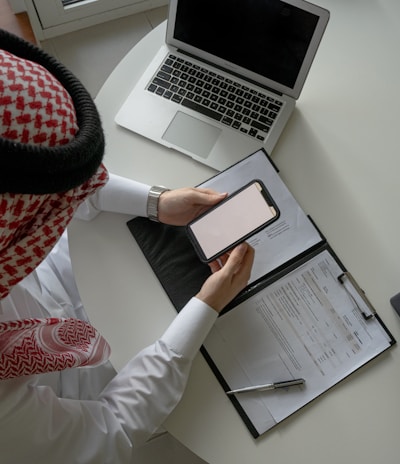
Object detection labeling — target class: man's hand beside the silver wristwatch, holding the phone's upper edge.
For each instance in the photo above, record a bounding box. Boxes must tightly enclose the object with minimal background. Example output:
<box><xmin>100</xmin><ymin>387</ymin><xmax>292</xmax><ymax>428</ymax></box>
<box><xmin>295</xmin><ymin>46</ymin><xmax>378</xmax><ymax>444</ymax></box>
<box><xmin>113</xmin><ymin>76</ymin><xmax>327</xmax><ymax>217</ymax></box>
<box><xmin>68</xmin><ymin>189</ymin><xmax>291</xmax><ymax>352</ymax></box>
<box><xmin>158</xmin><ymin>187</ymin><xmax>227</xmax><ymax>226</ymax></box>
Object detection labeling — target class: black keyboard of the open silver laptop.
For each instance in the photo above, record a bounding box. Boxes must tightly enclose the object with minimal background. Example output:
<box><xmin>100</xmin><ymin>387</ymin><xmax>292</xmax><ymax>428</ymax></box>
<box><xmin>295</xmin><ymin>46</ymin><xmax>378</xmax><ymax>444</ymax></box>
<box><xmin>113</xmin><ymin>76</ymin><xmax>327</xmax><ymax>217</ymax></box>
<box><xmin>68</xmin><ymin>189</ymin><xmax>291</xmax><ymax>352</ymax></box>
<box><xmin>147</xmin><ymin>54</ymin><xmax>283</xmax><ymax>141</ymax></box>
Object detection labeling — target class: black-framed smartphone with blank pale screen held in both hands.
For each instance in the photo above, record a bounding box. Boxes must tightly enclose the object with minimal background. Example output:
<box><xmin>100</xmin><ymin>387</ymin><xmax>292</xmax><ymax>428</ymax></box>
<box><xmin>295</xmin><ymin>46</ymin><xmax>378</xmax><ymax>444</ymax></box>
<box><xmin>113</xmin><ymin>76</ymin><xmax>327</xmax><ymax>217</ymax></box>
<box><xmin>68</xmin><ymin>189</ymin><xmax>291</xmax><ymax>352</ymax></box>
<box><xmin>187</xmin><ymin>179</ymin><xmax>279</xmax><ymax>263</ymax></box>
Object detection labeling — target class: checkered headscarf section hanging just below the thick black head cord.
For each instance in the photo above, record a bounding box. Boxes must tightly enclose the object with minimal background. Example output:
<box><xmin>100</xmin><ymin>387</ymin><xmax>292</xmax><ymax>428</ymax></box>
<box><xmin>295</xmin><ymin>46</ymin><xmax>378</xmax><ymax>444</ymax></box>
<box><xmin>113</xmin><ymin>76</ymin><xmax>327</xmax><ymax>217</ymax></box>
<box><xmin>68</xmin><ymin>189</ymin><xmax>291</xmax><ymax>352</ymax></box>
<box><xmin>0</xmin><ymin>166</ymin><xmax>108</xmax><ymax>298</ymax></box>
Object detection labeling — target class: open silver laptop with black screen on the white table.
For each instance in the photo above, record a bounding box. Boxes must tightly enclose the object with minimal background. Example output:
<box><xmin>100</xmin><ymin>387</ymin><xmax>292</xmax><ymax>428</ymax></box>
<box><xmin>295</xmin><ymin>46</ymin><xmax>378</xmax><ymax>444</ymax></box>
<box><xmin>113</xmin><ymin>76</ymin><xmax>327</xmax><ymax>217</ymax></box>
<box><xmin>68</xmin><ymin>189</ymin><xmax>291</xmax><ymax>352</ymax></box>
<box><xmin>115</xmin><ymin>0</ymin><xmax>329</xmax><ymax>171</ymax></box>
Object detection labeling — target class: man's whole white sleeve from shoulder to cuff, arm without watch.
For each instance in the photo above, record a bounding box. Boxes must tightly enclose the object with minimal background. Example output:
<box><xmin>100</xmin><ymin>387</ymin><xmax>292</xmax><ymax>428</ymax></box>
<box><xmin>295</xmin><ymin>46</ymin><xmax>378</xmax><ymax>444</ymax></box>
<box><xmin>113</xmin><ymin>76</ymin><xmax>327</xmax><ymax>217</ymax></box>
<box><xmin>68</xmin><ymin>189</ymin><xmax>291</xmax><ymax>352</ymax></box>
<box><xmin>0</xmin><ymin>298</ymin><xmax>217</xmax><ymax>464</ymax></box>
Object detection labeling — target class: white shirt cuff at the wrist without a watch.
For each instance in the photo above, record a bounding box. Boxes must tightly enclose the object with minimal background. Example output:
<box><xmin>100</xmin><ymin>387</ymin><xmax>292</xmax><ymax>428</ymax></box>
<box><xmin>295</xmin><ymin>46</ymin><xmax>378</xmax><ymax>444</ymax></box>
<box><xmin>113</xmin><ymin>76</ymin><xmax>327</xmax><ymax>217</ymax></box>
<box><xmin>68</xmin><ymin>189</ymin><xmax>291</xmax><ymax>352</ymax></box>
<box><xmin>161</xmin><ymin>297</ymin><xmax>218</xmax><ymax>360</ymax></box>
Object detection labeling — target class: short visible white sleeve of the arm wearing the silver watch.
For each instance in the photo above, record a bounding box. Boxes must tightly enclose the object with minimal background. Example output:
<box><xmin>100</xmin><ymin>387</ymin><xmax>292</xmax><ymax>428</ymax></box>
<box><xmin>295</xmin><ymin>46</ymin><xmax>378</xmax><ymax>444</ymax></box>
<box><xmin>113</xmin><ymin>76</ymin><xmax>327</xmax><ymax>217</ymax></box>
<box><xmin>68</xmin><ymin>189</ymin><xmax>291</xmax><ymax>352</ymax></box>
<box><xmin>75</xmin><ymin>173</ymin><xmax>151</xmax><ymax>220</ymax></box>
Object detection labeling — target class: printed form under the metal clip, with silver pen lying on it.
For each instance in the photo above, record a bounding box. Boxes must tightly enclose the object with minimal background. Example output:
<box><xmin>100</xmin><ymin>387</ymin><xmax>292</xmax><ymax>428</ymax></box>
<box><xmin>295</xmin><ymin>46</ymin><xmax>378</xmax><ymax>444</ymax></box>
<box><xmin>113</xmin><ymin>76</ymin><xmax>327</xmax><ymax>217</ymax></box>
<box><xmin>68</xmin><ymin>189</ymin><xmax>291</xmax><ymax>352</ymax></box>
<box><xmin>204</xmin><ymin>250</ymin><xmax>392</xmax><ymax>434</ymax></box>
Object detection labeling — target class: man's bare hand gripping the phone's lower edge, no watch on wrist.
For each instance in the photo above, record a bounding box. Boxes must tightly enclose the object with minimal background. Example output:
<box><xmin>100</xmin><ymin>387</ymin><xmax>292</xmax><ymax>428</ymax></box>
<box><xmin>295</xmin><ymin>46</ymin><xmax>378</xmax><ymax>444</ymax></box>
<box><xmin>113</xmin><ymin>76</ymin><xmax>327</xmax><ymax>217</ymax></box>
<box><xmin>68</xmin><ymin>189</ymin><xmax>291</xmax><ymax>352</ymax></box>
<box><xmin>196</xmin><ymin>243</ymin><xmax>254</xmax><ymax>313</ymax></box>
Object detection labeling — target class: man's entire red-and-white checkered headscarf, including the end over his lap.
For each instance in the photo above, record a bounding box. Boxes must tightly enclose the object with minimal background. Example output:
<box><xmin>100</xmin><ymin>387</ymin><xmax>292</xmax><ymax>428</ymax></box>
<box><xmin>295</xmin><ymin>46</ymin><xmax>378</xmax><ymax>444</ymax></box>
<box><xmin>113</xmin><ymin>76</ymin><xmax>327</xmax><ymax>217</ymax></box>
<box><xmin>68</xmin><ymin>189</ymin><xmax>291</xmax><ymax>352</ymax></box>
<box><xmin>0</xmin><ymin>50</ymin><xmax>110</xmax><ymax>380</ymax></box>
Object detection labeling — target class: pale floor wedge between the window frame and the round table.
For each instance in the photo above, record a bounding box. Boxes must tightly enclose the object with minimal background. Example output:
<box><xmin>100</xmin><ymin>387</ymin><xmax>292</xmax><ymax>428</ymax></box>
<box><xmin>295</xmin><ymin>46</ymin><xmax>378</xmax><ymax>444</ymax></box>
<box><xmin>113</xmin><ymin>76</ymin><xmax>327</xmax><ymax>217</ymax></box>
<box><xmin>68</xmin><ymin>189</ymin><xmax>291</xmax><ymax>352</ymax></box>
<box><xmin>41</xmin><ymin>6</ymin><xmax>167</xmax><ymax>97</ymax></box>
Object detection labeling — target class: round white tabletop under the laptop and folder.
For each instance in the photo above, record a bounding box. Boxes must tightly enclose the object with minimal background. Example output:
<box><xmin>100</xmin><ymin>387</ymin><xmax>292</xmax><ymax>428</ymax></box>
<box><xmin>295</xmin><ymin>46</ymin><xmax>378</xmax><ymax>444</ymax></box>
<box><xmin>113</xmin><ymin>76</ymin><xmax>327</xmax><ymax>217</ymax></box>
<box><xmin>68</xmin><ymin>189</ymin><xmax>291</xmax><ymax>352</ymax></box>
<box><xmin>70</xmin><ymin>0</ymin><xmax>400</xmax><ymax>464</ymax></box>
